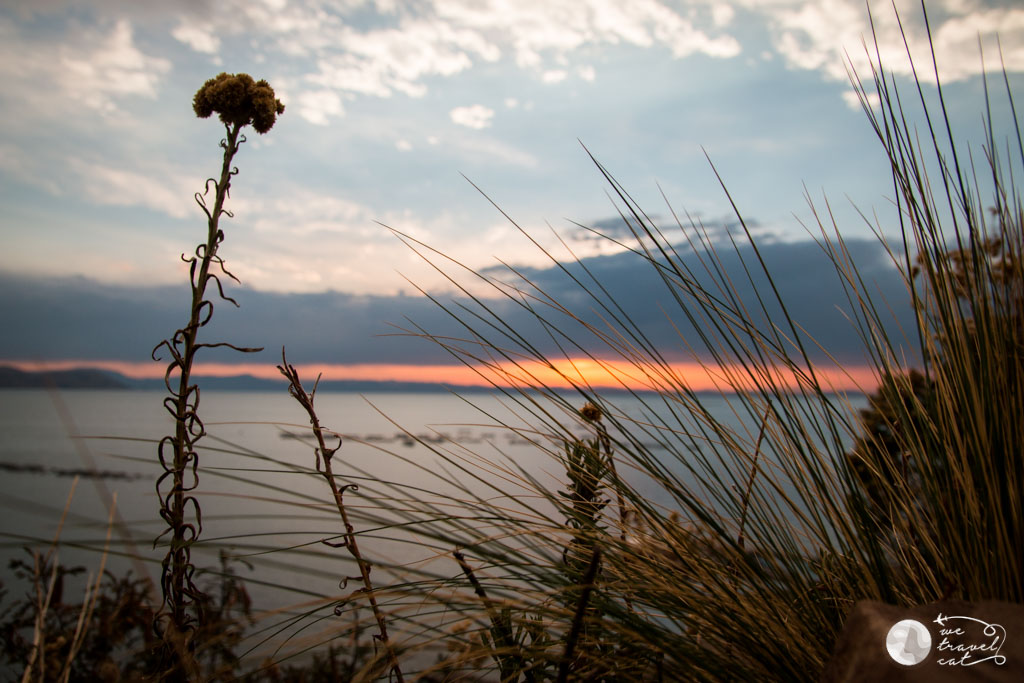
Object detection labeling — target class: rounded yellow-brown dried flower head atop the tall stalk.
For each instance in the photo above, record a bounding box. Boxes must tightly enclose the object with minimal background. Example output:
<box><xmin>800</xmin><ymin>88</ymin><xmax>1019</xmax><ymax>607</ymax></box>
<box><xmin>193</xmin><ymin>74</ymin><xmax>285</xmax><ymax>133</ymax></box>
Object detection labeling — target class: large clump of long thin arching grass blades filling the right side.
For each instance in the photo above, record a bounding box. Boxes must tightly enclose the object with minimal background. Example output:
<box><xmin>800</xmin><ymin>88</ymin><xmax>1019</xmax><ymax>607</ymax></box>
<box><xmin>380</xmin><ymin>7</ymin><xmax>1024</xmax><ymax>681</ymax></box>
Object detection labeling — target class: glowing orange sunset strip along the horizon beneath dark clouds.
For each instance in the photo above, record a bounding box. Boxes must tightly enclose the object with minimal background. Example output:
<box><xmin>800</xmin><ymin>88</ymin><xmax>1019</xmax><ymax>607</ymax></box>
<box><xmin>10</xmin><ymin>358</ymin><xmax>878</xmax><ymax>392</ymax></box>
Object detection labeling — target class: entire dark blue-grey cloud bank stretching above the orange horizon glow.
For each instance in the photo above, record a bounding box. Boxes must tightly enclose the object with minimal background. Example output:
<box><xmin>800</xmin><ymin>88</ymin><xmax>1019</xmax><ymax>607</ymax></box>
<box><xmin>0</xmin><ymin>235</ymin><xmax>913</xmax><ymax>374</ymax></box>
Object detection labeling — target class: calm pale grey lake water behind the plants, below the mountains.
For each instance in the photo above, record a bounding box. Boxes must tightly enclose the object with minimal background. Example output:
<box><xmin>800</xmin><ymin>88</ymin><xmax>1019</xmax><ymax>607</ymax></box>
<box><xmin>0</xmin><ymin>390</ymin><xmax>863</xmax><ymax>667</ymax></box>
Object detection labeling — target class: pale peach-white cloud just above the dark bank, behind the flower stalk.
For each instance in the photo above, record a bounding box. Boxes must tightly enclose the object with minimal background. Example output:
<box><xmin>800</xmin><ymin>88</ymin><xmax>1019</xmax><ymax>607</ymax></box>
<box><xmin>0</xmin><ymin>150</ymin><xmax>534</xmax><ymax>293</ymax></box>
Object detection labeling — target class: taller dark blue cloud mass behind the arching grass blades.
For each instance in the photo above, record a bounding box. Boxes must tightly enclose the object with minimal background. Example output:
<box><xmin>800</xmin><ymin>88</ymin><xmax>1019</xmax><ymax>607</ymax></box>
<box><xmin>475</xmin><ymin>231</ymin><xmax>915</xmax><ymax>365</ymax></box>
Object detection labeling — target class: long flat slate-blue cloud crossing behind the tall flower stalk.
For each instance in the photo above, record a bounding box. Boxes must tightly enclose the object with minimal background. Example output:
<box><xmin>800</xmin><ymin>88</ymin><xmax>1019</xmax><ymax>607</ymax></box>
<box><xmin>0</xmin><ymin>272</ymin><xmax>458</xmax><ymax>362</ymax></box>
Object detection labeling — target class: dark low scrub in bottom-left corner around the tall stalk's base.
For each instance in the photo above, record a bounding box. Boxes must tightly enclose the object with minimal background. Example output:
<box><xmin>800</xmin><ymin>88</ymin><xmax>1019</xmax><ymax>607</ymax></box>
<box><xmin>0</xmin><ymin>553</ymin><xmax>331</xmax><ymax>683</ymax></box>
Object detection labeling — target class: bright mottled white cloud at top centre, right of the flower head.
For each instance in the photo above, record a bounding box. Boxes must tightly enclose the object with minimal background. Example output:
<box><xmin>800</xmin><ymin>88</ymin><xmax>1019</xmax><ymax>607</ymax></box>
<box><xmin>134</xmin><ymin>0</ymin><xmax>739</xmax><ymax>108</ymax></box>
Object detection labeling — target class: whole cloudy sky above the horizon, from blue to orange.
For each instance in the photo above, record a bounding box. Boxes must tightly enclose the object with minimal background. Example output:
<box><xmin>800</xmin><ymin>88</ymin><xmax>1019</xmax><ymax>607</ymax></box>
<box><xmin>0</xmin><ymin>0</ymin><xmax>1024</xmax><ymax>389</ymax></box>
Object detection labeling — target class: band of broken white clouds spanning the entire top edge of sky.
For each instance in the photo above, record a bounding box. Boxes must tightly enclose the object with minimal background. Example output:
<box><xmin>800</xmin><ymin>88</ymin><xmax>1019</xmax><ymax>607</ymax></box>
<box><xmin>0</xmin><ymin>0</ymin><xmax>1024</xmax><ymax>131</ymax></box>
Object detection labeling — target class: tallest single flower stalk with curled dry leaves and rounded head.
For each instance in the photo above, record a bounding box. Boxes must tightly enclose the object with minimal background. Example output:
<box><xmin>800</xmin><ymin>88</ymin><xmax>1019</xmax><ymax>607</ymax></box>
<box><xmin>153</xmin><ymin>74</ymin><xmax>285</xmax><ymax>678</ymax></box>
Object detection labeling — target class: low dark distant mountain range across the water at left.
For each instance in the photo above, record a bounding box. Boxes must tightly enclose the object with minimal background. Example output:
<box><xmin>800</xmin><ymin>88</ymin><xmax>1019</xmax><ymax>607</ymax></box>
<box><xmin>0</xmin><ymin>366</ymin><xmax>492</xmax><ymax>393</ymax></box>
